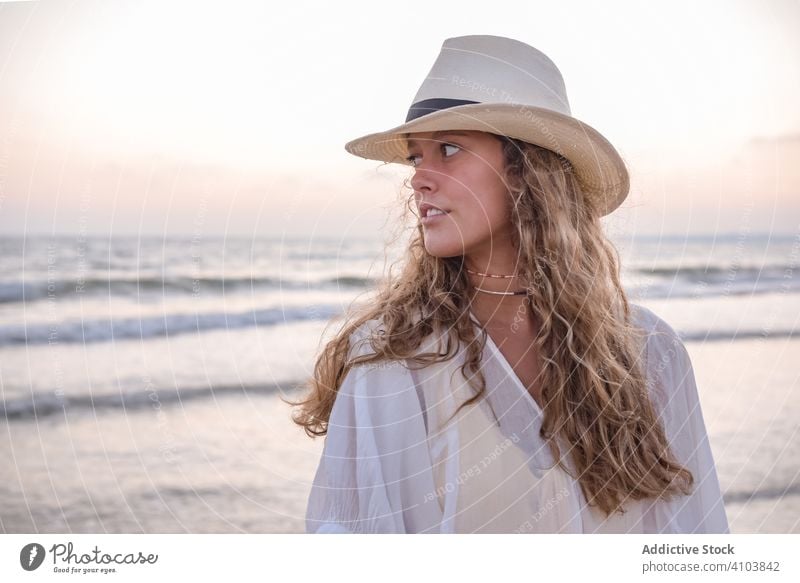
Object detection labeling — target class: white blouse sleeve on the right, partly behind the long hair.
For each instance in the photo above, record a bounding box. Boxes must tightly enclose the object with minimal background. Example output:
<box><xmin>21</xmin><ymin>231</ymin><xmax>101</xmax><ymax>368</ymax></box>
<box><xmin>645</xmin><ymin>312</ymin><xmax>729</xmax><ymax>533</ymax></box>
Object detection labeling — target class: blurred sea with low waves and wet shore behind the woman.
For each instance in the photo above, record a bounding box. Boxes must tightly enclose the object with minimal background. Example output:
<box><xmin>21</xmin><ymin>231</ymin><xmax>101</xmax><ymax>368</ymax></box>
<box><xmin>0</xmin><ymin>233</ymin><xmax>800</xmax><ymax>533</ymax></box>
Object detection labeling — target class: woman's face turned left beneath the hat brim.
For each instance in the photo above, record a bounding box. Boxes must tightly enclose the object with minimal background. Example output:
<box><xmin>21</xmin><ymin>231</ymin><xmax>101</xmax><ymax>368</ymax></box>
<box><xmin>408</xmin><ymin>131</ymin><xmax>511</xmax><ymax>257</ymax></box>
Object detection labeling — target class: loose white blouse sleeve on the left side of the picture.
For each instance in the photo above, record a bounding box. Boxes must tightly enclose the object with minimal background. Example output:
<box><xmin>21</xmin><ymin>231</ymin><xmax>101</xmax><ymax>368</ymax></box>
<box><xmin>306</xmin><ymin>324</ymin><xmax>441</xmax><ymax>533</ymax></box>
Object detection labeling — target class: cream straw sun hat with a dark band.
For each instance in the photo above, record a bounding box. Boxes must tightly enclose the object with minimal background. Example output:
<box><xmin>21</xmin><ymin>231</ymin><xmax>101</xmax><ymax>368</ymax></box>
<box><xmin>345</xmin><ymin>35</ymin><xmax>630</xmax><ymax>215</ymax></box>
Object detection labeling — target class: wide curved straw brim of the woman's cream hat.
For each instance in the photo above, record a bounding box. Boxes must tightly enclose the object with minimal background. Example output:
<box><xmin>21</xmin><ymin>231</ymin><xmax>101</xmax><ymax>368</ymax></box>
<box><xmin>345</xmin><ymin>103</ymin><xmax>630</xmax><ymax>215</ymax></box>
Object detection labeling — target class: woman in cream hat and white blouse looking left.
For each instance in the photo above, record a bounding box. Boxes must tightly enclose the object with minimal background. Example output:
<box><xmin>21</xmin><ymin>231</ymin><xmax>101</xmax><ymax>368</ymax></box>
<box><xmin>295</xmin><ymin>36</ymin><xmax>728</xmax><ymax>533</ymax></box>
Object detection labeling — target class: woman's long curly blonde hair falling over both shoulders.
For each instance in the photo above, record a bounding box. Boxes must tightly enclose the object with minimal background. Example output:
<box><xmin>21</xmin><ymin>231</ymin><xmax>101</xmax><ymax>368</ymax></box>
<box><xmin>287</xmin><ymin>136</ymin><xmax>694</xmax><ymax>515</ymax></box>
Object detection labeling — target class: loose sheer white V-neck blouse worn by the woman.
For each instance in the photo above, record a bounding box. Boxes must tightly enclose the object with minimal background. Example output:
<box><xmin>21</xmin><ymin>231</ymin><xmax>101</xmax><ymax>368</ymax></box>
<box><xmin>306</xmin><ymin>304</ymin><xmax>729</xmax><ymax>533</ymax></box>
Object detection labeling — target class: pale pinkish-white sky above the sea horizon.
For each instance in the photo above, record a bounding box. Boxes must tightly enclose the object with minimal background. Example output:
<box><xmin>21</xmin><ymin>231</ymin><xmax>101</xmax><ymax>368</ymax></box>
<box><xmin>0</xmin><ymin>0</ymin><xmax>800</xmax><ymax>236</ymax></box>
